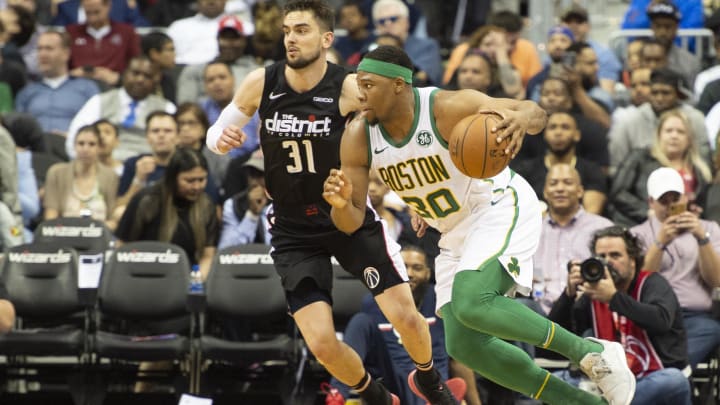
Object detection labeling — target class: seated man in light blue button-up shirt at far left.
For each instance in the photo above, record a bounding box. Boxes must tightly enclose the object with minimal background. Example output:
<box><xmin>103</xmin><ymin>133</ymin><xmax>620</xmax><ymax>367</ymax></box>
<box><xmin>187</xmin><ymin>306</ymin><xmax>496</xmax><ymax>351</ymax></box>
<box><xmin>15</xmin><ymin>30</ymin><xmax>99</xmax><ymax>136</ymax></box>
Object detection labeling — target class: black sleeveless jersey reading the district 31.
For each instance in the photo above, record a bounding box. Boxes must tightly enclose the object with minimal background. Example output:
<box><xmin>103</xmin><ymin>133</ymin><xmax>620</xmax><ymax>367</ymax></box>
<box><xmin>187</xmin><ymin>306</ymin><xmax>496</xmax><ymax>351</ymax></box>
<box><xmin>258</xmin><ymin>61</ymin><xmax>349</xmax><ymax>211</ymax></box>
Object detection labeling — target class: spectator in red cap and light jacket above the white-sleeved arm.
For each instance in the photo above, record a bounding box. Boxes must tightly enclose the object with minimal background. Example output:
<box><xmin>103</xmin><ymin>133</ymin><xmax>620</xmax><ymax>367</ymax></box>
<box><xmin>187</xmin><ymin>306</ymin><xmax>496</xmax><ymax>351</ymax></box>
<box><xmin>177</xmin><ymin>16</ymin><xmax>262</xmax><ymax>103</ymax></box>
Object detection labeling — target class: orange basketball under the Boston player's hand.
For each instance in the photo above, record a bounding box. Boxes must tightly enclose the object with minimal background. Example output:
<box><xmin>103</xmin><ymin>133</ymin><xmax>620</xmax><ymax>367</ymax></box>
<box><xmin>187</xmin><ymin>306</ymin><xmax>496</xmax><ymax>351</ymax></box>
<box><xmin>448</xmin><ymin>113</ymin><xmax>510</xmax><ymax>179</ymax></box>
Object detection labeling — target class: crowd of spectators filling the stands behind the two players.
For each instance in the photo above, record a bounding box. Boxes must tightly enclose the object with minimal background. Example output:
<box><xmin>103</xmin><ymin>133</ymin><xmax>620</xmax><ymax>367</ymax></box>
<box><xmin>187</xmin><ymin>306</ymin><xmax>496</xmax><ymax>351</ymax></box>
<box><xmin>0</xmin><ymin>0</ymin><xmax>720</xmax><ymax>402</ymax></box>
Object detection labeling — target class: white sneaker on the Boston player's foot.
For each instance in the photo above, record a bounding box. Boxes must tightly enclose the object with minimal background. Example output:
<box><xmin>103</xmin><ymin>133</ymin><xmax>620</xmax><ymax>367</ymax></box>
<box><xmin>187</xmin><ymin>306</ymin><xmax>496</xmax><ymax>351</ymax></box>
<box><xmin>580</xmin><ymin>338</ymin><xmax>635</xmax><ymax>405</ymax></box>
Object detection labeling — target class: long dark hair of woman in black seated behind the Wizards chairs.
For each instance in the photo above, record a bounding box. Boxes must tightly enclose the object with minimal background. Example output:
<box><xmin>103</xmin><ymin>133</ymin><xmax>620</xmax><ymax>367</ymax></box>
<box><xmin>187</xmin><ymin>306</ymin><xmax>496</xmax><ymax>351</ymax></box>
<box><xmin>158</xmin><ymin>147</ymin><xmax>215</xmax><ymax>259</ymax></box>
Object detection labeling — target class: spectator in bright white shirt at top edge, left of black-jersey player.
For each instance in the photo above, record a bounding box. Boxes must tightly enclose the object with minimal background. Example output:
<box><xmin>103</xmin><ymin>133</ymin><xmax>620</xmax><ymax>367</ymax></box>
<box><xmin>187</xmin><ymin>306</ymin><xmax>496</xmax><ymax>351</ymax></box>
<box><xmin>167</xmin><ymin>0</ymin><xmax>226</xmax><ymax>65</ymax></box>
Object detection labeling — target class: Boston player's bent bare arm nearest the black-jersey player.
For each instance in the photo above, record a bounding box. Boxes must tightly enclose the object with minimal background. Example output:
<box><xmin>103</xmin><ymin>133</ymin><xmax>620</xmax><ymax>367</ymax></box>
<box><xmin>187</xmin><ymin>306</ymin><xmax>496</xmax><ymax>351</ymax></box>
<box><xmin>323</xmin><ymin>117</ymin><xmax>369</xmax><ymax>234</ymax></box>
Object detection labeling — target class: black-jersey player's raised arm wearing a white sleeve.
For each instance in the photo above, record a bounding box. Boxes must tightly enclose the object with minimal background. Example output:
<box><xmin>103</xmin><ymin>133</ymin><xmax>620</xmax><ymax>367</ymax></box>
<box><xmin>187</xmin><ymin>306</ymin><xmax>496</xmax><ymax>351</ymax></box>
<box><xmin>205</xmin><ymin>68</ymin><xmax>265</xmax><ymax>155</ymax></box>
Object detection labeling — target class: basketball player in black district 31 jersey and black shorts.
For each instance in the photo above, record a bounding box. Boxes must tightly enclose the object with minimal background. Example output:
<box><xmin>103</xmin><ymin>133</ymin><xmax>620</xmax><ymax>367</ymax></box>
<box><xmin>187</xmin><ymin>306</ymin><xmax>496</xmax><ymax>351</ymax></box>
<box><xmin>207</xmin><ymin>0</ymin><xmax>464</xmax><ymax>405</ymax></box>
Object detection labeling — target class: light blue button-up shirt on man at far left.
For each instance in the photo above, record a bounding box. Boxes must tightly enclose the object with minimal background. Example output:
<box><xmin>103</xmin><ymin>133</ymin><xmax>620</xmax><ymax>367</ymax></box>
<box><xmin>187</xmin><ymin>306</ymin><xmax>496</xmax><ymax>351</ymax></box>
<box><xmin>15</xmin><ymin>77</ymin><xmax>100</xmax><ymax>132</ymax></box>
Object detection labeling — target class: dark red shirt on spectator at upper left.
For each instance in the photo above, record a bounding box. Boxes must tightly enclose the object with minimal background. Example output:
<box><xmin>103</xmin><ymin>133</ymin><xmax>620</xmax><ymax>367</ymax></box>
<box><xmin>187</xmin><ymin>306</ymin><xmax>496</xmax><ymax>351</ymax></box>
<box><xmin>67</xmin><ymin>22</ymin><xmax>140</xmax><ymax>73</ymax></box>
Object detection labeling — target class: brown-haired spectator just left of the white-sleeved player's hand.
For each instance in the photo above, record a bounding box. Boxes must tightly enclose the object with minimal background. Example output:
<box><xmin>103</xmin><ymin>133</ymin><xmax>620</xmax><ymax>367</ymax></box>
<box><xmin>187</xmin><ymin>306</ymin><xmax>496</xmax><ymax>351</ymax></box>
<box><xmin>175</xmin><ymin>103</ymin><xmax>229</xmax><ymax>195</ymax></box>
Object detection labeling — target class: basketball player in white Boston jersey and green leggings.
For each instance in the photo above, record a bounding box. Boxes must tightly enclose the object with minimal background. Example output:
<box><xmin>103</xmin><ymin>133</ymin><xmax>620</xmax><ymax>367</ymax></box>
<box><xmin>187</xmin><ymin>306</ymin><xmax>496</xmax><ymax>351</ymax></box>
<box><xmin>323</xmin><ymin>47</ymin><xmax>635</xmax><ymax>405</ymax></box>
